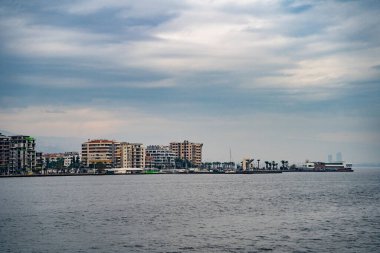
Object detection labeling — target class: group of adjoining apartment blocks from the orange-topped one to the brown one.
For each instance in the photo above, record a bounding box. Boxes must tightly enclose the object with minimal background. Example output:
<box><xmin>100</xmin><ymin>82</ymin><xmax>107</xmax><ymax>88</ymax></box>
<box><xmin>81</xmin><ymin>140</ymin><xmax>203</xmax><ymax>169</ymax></box>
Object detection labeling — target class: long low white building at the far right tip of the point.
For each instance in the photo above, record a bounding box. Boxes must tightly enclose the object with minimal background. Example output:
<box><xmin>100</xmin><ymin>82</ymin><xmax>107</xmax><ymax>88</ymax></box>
<box><xmin>297</xmin><ymin>162</ymin><xmax>353</xmax><ymax>172</ymax></box>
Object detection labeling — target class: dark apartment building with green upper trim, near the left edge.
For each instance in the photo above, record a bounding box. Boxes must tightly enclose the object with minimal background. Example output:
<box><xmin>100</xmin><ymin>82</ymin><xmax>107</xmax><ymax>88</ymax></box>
<box><xmin>9</xmin><ymin>135</ymin><xmax>36</xmax><ymax>174</ymax></box>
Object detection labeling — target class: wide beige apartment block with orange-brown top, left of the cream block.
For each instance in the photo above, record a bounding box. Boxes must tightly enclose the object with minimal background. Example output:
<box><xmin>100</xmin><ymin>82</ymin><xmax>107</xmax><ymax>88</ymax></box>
<box><xmin>81</xmin><ymin>140</ymin><xmax>120</xmax><ymax>167</ymax></box>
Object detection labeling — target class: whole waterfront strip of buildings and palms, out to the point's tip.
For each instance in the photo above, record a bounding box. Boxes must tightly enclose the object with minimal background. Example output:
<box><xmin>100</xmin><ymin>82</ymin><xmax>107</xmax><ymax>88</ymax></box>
<box><xmin>0</xmin><ymin>133</ymin><xmax>352</xmax><ymax>175</ymax></box>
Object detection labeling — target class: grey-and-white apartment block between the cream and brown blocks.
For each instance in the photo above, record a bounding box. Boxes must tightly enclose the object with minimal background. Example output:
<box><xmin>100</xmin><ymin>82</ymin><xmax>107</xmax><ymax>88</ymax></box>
<box><xmin>145</xmin><ymin>145</ymin><xmax>176</xmax><ymax>169</ymax></box>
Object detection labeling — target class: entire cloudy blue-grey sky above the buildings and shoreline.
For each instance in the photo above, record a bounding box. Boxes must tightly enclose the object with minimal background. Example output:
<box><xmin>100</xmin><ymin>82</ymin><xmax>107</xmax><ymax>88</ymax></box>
<box><xmin>0</xmin><ymin>0</ymin><xmax>380</xmax><ymax>162</ymax></box>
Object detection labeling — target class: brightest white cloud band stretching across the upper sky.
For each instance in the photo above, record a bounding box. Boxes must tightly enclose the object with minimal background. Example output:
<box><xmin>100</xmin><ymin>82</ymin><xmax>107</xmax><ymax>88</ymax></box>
<box><xmin>1</xmin><ymin>0</ymin><xmax>379</xmax><ymax>93</ymax></box>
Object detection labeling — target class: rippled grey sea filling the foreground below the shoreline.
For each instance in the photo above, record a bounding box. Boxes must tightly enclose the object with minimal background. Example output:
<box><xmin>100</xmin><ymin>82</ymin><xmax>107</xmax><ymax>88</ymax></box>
<box><xmin>0</xmin><ymin>168</ymin><xmax>380</xmax><ymax>253</ymax></box>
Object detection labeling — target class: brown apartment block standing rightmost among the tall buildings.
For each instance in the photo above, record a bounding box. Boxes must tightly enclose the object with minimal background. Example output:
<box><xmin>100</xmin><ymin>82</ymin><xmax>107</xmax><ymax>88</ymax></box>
<box><xmin>170</xmin><ymin>140</ymin><xmax>203</xmax><ymax>166</ymax></box>
